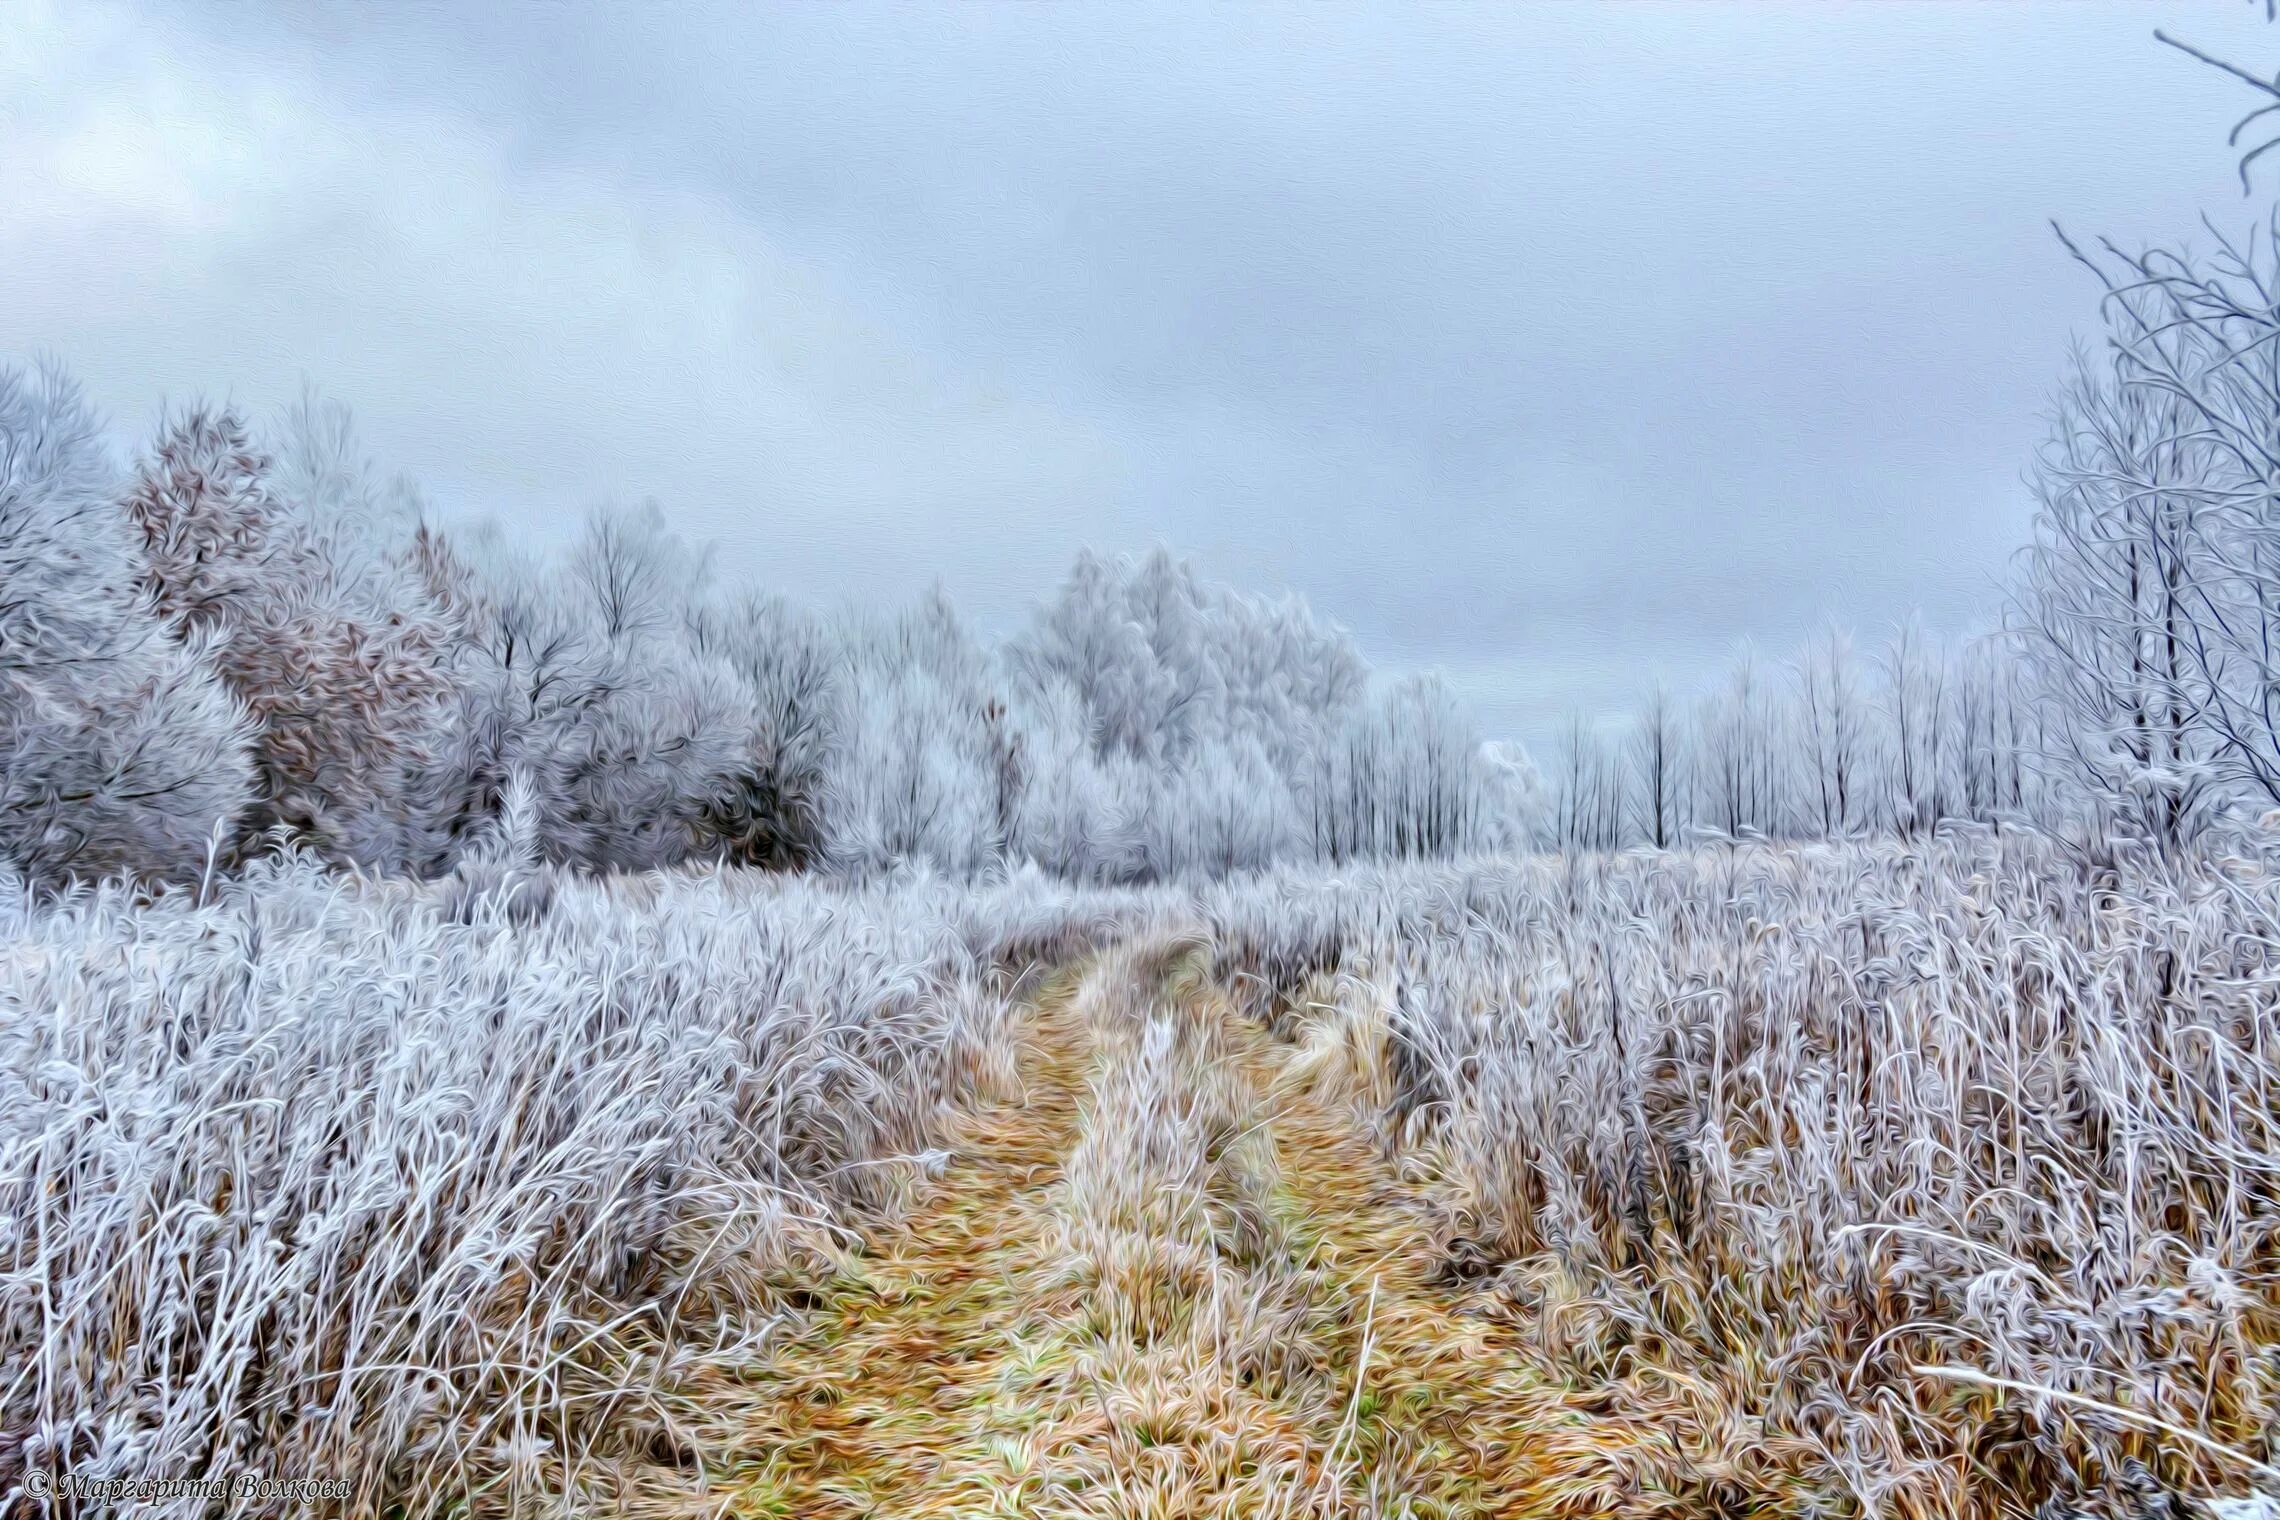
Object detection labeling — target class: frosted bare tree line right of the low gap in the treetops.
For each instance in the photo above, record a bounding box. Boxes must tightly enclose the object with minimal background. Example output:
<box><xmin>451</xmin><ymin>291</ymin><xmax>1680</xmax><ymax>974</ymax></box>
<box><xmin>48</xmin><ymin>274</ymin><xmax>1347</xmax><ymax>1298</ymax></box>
<box><xmin>1544</xmin><ymin>23</ymin><xmax>2280</xmax><ymax>850</ymax></box>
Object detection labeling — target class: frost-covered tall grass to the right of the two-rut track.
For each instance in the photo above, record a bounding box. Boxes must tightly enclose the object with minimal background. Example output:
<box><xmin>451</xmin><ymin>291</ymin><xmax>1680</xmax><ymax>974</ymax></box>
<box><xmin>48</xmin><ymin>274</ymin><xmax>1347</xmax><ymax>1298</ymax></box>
<box><xmin>1213</xmin><ymin>834</ymin><xmax>2280</xmax><ymax>1520</ymax></box>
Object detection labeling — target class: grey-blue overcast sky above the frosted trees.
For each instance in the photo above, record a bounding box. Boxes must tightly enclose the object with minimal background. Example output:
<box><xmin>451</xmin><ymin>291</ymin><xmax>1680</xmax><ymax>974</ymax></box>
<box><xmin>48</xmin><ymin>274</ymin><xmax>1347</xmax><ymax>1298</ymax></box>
<box><xmin>0</xmin><ymin>0</ymin><xmax>2280</xmax><ymax>756</ymax></box>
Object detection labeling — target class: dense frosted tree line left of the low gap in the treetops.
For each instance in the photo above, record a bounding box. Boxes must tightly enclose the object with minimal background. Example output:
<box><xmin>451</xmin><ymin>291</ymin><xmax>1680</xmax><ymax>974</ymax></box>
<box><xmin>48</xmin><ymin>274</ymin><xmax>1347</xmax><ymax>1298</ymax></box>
<box><xmin>0</xmin><ymin>367</ymin><xmax>1530</xmax><ymax>886</ymax></box>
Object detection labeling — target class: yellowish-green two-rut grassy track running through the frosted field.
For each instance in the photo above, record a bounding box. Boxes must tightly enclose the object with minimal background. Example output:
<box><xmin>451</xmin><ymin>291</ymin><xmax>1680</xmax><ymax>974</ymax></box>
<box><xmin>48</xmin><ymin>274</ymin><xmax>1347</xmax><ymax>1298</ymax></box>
<box><xmin>642</xmin><ymin>948</ymin><xmax>1621</xmax><ymax>1520</ymax></box>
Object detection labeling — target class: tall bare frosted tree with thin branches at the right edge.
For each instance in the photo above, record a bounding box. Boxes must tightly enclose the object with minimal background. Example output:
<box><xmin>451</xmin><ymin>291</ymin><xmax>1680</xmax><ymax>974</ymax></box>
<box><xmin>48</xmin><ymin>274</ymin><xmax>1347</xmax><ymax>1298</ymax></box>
<box><xmin>2020</xmin><ymin>272</ymin><xmax>2280</xmax><ymax>843</ymax></box>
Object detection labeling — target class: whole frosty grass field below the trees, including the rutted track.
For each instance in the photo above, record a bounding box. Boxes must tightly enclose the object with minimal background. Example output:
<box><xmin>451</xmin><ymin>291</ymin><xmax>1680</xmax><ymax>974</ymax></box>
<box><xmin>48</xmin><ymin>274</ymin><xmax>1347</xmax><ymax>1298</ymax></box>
<box><xmin>0</xmin><ymin>834</ymin><xmax>2280</xmax><ymax>1520</ymax></box>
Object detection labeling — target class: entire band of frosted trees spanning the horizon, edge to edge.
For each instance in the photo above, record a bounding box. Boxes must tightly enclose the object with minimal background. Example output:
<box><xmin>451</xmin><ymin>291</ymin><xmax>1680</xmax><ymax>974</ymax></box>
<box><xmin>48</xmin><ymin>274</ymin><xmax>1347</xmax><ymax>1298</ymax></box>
<box><xmin>13</xmin><ymin>14</ymin><xmax>2280</xmax><ymax>886</ymax></box>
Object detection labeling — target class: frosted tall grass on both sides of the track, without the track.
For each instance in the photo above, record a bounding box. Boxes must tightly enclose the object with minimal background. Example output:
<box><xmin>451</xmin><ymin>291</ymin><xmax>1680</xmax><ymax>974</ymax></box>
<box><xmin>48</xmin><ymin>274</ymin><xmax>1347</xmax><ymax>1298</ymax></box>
<box><xmin>0</xmin><ymin>834</ymin><xmax>2280</xmax><ymax>1520</ymax></box>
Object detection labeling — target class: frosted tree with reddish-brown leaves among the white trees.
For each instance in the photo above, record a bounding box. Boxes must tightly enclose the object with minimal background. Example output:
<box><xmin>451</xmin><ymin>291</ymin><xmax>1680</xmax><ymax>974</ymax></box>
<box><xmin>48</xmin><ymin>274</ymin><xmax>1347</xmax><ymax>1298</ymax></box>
<box><xmin>125</xmin><ymin>398</ymin><xmax>454</xmax><ymax>868</ymax></box>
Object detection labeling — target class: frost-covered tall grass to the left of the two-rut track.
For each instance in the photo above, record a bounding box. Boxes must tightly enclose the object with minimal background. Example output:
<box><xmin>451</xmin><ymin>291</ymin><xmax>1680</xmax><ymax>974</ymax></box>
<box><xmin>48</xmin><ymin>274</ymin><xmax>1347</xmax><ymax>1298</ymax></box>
<box><xmin>0</xmin><ymin>866</ymin><xmax>1030</xmax><ymax>1511</ymax></box>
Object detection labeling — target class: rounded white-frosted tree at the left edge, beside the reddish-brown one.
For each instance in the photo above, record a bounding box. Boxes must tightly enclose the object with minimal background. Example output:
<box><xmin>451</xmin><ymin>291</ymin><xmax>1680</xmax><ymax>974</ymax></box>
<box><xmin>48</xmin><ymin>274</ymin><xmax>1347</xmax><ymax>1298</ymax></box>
<box><xmin>0</xmin><ymin>369</ymin><xmax>251</xmax><ymax>886</ymax></box>
